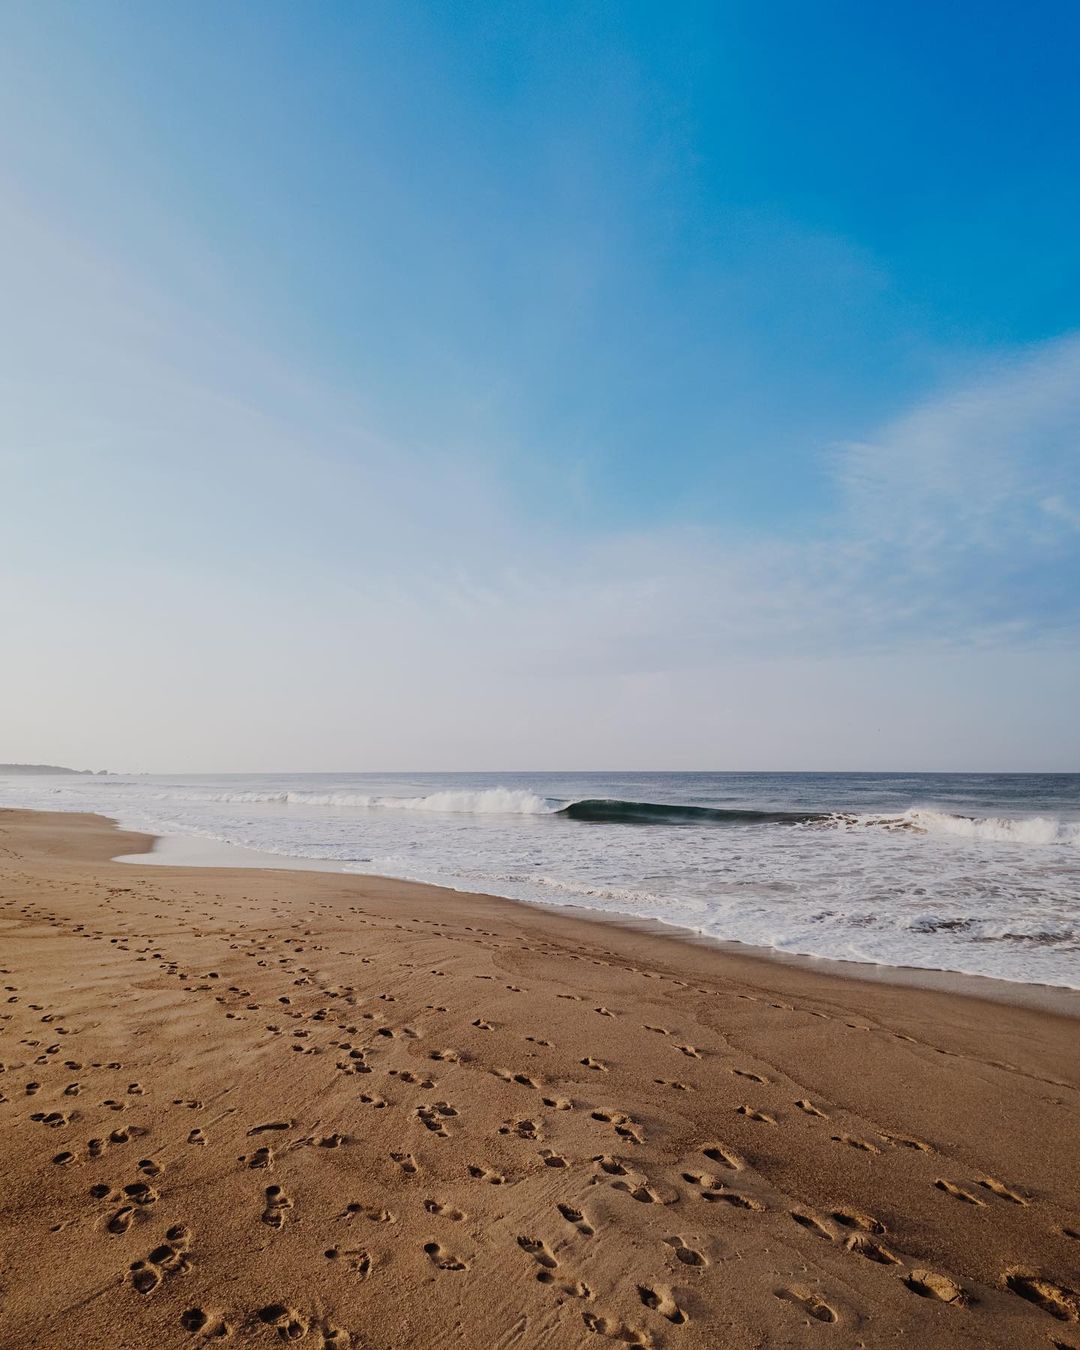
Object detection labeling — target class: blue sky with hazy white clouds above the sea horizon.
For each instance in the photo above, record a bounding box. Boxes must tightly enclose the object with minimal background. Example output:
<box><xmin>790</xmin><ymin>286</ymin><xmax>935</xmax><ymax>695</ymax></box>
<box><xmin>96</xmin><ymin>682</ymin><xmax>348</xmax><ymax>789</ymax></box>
<box><xmin>0</xmin><ymin>0</ymin><xmax>1080</xmax><ymax>771</ymax></box>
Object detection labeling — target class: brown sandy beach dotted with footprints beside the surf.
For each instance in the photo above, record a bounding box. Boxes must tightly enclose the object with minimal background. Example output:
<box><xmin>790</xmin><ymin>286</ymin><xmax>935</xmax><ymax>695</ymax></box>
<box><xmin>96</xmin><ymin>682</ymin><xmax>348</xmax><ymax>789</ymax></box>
<box><xmin>0</xmin><ymin>811</ymin><xmax>1080</xmax><ymax>1350</ymax></box>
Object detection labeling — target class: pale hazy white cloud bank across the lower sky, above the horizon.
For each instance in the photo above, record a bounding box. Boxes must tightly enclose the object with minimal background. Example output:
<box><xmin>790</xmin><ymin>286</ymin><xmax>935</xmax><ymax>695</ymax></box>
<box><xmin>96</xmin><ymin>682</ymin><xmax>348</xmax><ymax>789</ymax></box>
<box><xmin>0</xmin><ymin>178</ymin><xmax>1080</xmax><ymax>768</ymax></box>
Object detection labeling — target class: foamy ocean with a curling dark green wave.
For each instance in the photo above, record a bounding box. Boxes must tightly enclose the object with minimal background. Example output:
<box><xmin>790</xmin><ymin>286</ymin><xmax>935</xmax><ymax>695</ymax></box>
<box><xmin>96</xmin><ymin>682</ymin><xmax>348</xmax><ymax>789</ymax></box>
<box><xmin>0</xmin><ymin>774</ymin><xmax>1080</xmax><ymax>988</ymax></box>
